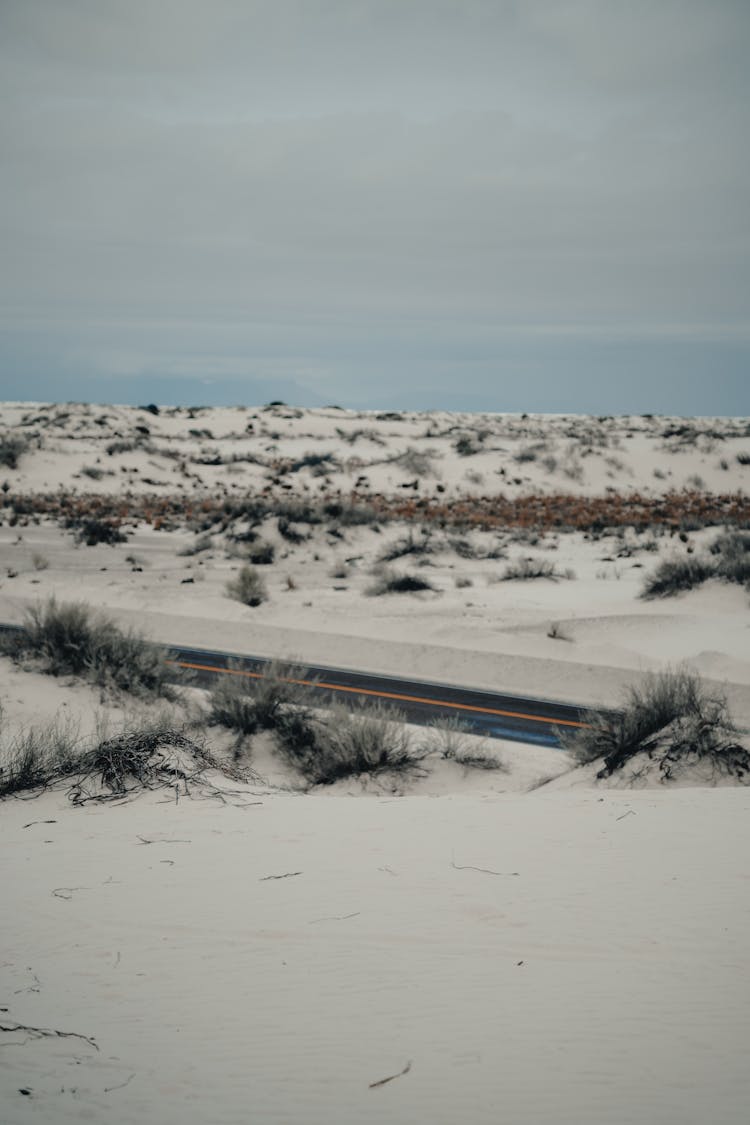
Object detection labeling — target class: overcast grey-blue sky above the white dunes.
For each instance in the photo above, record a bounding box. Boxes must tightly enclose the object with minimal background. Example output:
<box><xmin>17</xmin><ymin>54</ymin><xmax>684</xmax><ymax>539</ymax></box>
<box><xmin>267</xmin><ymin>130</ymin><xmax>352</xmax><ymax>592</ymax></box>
<box><xmin>0</xmin><ymin>0</ymin><xmax>750</xmax><ymax>415</ymax></box>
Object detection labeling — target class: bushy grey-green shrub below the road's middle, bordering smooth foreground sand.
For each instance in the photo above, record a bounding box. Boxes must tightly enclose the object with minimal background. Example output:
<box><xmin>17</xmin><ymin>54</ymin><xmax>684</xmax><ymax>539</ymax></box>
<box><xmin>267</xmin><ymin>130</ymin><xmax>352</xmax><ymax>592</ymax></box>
<box><xmin>277</xmin><ymin>704</ymin><xmax>418</xmax><ymax>785</ymax></box>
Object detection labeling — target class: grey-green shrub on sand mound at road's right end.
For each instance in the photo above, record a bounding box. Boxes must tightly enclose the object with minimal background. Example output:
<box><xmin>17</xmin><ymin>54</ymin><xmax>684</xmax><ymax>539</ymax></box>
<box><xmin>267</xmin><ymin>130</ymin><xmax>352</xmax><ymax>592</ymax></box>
<box><xmin>560</xmin><ymin>668</ymin><xmax>750</xmax><ymax>780</ymax></box>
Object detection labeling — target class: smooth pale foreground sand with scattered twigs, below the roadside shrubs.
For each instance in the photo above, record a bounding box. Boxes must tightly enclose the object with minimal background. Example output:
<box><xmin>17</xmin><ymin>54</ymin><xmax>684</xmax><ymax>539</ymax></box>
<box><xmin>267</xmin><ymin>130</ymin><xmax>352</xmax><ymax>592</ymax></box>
<box><xmin>0</xmin><ymin>789</ymin><xmax>750</xmax><ymax>1125</ymax></box>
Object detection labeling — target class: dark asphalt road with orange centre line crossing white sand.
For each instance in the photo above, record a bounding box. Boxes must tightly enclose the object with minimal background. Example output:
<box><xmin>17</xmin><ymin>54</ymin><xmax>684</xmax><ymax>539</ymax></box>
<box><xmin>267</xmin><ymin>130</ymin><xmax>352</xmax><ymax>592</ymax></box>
<box><xmin>0</xmin><ymin>623</ymin><xmax>586</xmax><ymax>747</ymax></box>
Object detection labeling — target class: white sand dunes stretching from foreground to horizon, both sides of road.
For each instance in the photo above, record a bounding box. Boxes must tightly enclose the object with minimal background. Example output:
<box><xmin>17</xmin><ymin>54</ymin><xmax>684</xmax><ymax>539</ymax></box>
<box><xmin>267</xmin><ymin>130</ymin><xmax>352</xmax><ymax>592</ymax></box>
<box><xmin>0</xmin><ymin>404</ymin><xmax>750</xmax><ymax>1125</ymax></box>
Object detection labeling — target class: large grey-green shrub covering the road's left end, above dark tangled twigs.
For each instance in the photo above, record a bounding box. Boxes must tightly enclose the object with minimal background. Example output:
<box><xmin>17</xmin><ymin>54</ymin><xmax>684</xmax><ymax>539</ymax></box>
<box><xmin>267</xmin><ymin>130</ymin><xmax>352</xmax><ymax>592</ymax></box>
<box><xmin>8</xmin><ymin>597</ymin><xmax>173</xmax><ymax>699</ymax></box>
